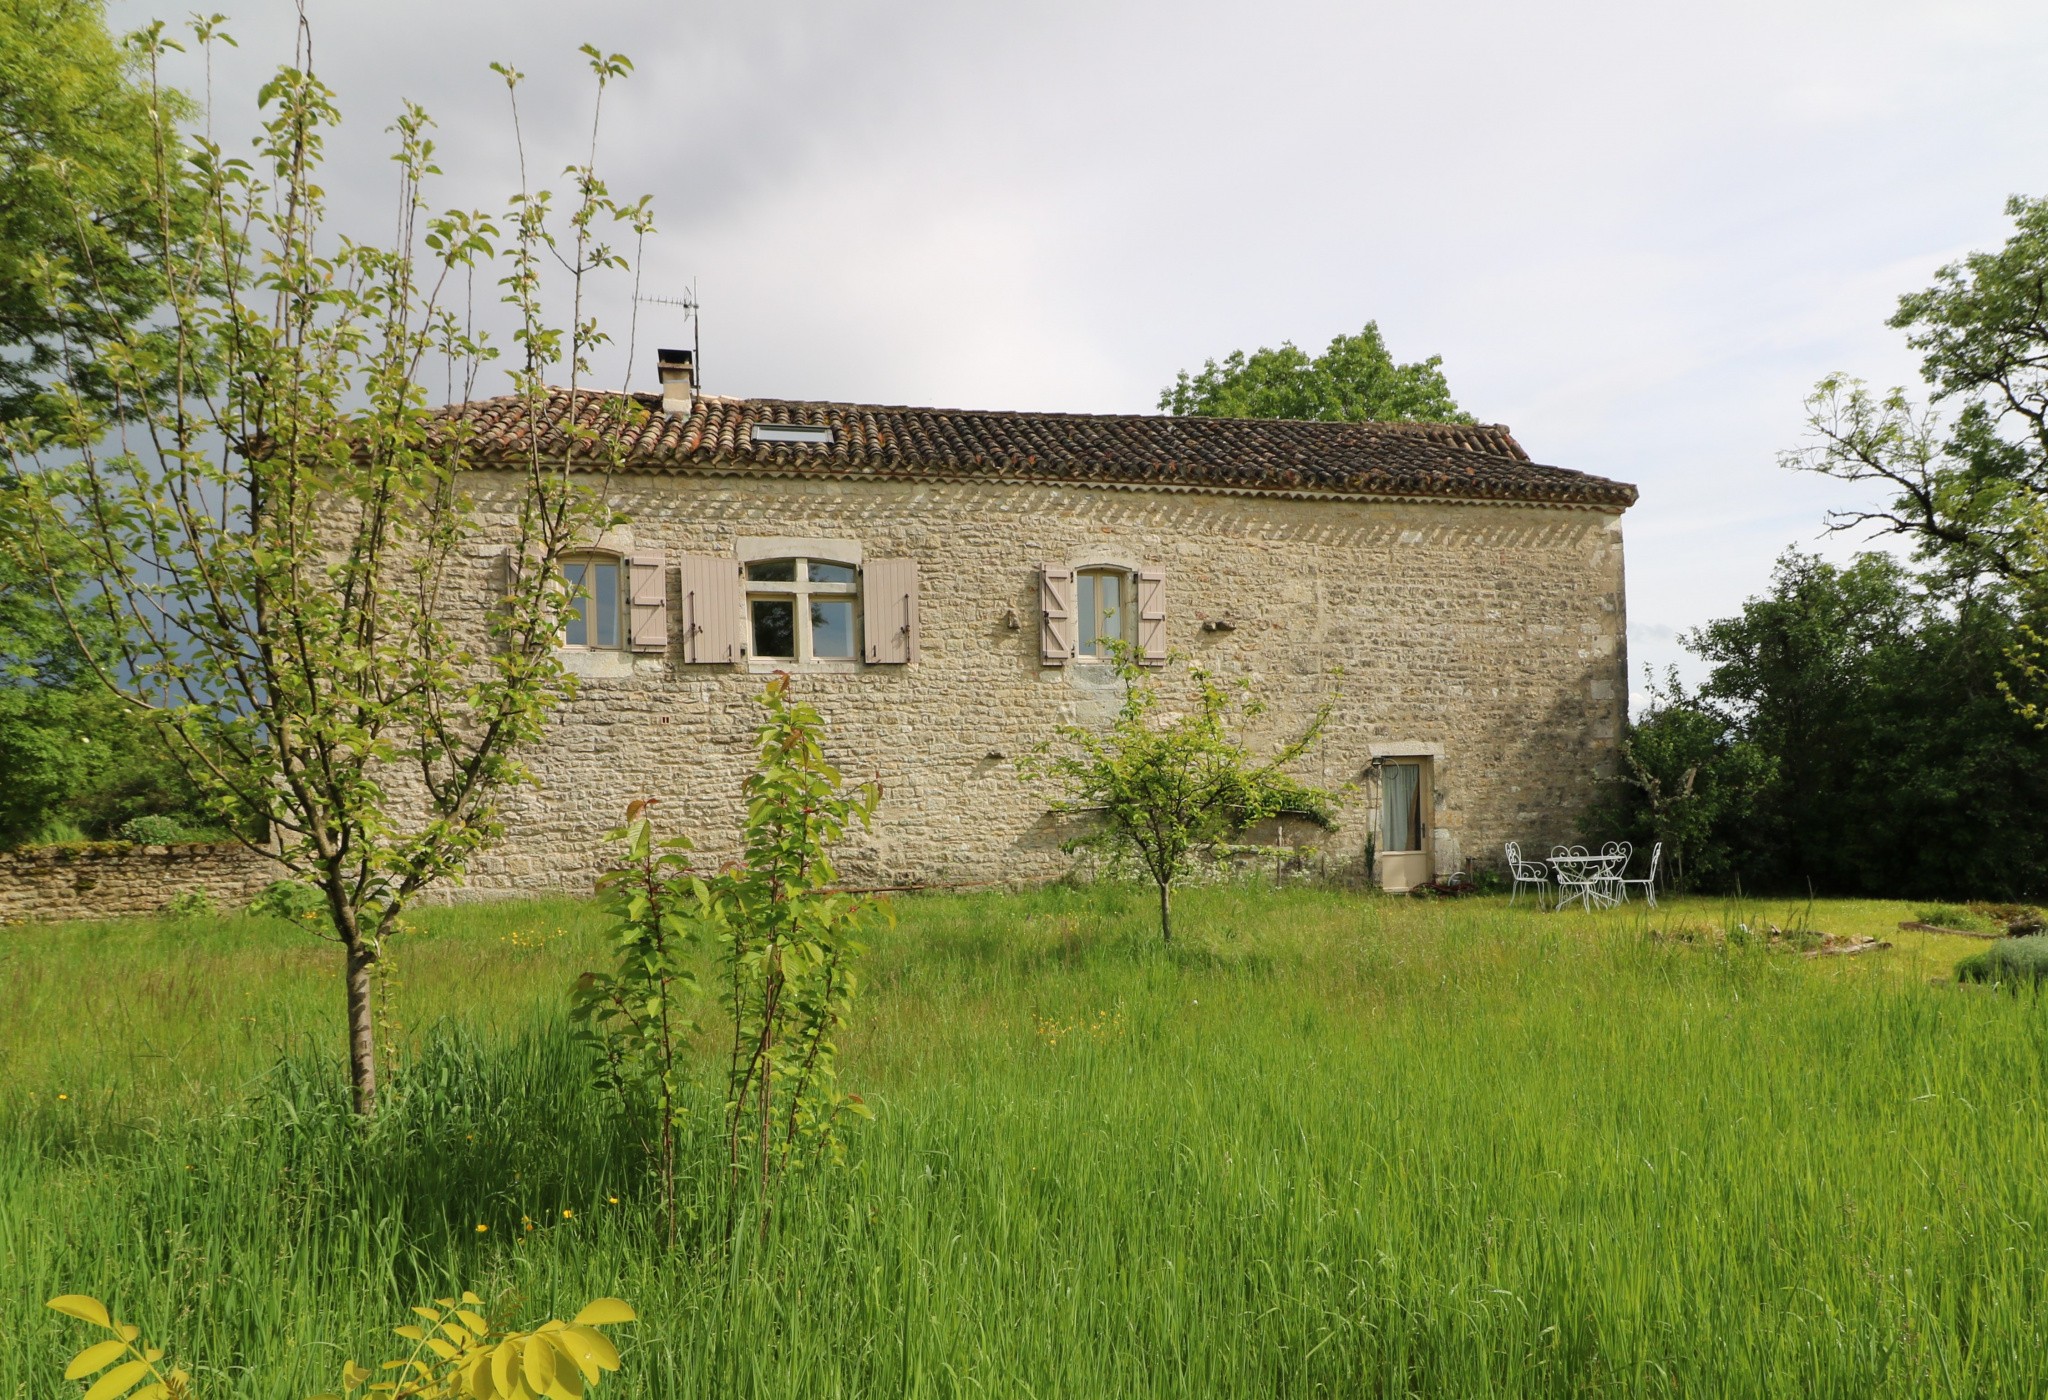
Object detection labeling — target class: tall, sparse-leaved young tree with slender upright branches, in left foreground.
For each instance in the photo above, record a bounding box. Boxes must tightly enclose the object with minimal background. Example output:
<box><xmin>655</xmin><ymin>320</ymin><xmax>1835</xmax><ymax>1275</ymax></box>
<box><xmin>6</xmin><ymin>23</ymin><xmax>647</xmax><ymax>1113</ymax></box>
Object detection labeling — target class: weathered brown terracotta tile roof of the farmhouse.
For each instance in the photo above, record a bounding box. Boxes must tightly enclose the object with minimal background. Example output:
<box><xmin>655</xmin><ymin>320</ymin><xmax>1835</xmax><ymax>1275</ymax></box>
<box><xmin>446</xmin><ymin>389</ymin><xmax>1636</xmax><ymax>510</ymax></box>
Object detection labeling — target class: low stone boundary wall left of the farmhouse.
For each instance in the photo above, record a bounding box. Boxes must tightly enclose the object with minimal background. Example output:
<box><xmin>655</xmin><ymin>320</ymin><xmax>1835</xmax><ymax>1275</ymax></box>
<box><xmin>0</xmin><ymin>841</ymin><xmax>285</xmax><ymax>923</ymax></box>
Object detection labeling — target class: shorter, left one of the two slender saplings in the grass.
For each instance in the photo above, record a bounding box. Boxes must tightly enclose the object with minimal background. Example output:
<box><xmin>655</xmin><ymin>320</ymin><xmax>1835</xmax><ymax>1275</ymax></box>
<box><xmin>571</xmin><ymin>798</ymin><xmax>717</xmax><ymax>1249</ymax></box>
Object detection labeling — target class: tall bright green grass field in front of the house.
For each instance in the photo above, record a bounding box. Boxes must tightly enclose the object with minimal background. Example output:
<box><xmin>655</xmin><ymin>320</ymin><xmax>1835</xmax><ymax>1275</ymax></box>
<box><xmin>0</xmin><ymin>888</ymin><xmax>2048</xmax><ymax>1400</ymax></box>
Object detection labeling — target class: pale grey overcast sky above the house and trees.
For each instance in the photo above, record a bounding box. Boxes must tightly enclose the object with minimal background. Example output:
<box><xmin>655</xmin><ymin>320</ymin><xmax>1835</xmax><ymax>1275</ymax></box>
<box><xmin>113</xmin><ymin>0</ymin><xmax>2048</xmax><ymax>700</ymax></box>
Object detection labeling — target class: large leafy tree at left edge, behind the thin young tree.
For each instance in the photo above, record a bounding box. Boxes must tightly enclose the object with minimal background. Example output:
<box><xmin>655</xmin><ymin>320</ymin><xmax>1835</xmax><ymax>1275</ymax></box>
<box><xmin>0</xmin><ymin>0</ymin><xmax>197</xmax><ymax>845</ymax></box>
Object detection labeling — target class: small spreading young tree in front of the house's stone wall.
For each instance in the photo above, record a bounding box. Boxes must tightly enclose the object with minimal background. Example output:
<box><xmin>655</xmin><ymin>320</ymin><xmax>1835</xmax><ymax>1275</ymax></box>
<box><xmin>1020</xmin><ymin>649</ymin><xmax>1335</xmax><ymax>942</ymax></box>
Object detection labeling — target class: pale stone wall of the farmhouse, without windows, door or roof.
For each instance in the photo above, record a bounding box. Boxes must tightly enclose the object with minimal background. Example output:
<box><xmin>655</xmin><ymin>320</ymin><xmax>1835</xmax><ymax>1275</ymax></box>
<box><xmin>436</xmin><ymin>471</ymin><xmax>1626</xmax><ymax>894</ymax></box>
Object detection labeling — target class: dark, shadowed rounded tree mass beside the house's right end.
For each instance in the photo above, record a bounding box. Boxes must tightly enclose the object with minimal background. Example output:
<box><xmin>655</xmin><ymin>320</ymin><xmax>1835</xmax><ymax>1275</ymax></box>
<box><xmin>1597</xmin><ymin>553</ymin><xmax>2048</xmax><ymax>899</ymax></box>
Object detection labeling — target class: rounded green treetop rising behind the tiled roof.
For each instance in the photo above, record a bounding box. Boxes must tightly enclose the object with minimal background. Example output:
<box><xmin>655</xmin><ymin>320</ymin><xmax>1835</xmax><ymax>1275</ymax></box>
<box><xmin>1159</xmin><ymin>321</ymin><xmax>1473</xmax><ymax>424</ymax></box>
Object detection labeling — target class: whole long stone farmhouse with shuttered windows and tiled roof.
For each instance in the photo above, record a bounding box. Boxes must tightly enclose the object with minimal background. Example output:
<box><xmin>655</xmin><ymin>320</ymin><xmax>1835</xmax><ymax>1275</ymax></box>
<box><xmin>451</xmin><ymin>352</ymin><xmax>1636</xmax><ymax>892</ymax></box>
